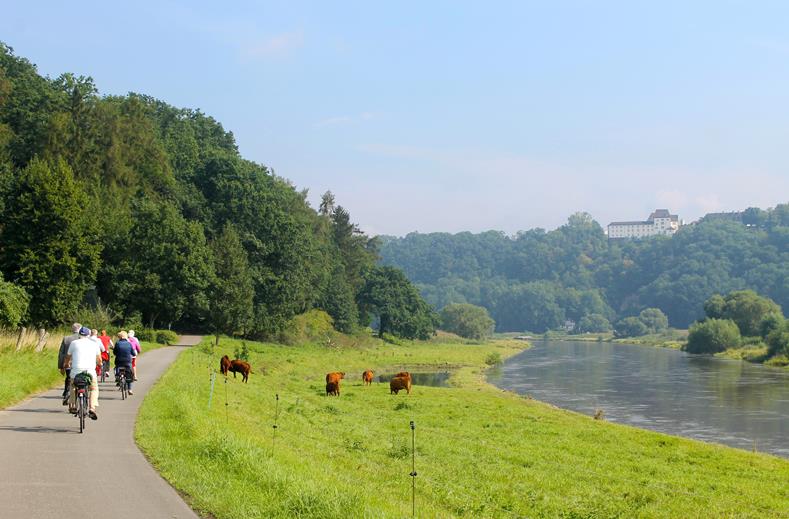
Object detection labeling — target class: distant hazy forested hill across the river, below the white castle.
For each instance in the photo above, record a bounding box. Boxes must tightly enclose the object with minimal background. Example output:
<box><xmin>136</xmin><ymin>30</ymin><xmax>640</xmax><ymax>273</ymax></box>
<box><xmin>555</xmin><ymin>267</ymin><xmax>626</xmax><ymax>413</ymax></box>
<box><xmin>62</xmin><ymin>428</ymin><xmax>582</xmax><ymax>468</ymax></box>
<box><xmin>381</xmin><ymin>209</ymin><xmax>789</xmax><ymax>332</ymax></box>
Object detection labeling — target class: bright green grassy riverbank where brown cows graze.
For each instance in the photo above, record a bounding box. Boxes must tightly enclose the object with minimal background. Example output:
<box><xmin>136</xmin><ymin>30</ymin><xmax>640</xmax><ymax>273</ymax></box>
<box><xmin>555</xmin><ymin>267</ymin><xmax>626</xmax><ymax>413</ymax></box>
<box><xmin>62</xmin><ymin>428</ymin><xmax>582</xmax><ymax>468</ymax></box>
<box><xmin>136</xmin><ymin>341</ymin><xmax>789</xmax><ymax>519</ymax></box>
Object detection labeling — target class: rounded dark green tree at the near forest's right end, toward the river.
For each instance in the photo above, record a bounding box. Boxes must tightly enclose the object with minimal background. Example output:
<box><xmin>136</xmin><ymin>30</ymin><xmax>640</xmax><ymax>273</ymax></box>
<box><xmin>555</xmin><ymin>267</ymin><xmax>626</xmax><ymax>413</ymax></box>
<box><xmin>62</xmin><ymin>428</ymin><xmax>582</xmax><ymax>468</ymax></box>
<box><xmin>357</xmin><ymin>267</ymin><xmax>438</xmax><ymax>339</ymax></box>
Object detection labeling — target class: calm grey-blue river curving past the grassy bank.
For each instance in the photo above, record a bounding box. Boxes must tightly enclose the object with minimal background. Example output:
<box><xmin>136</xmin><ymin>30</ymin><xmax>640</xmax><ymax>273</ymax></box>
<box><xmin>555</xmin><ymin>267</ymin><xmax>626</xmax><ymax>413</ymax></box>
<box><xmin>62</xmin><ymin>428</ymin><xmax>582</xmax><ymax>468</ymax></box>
<box><xmin>489</xmin><ymin>341</ymin><xmax>789</xmax><ymax>458</ymax></box>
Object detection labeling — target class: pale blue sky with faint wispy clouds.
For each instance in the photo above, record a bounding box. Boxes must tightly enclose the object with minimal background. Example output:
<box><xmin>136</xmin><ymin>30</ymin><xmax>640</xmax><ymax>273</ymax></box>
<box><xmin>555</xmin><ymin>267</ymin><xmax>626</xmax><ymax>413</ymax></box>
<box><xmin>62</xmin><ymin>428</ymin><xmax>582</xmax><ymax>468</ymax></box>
<box><xmin>0</xmin><ymin>0</ymin><xmax>789</xmax><ymax>235</ymax></box>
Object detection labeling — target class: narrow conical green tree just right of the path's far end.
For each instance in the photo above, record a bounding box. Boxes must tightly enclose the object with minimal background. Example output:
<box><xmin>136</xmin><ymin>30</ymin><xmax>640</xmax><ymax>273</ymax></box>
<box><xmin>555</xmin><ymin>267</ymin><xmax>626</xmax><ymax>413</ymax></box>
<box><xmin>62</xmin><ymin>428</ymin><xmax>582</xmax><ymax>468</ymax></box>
<box><xmin>209</xmin><ymin>223</ymin><xmax>255</xmax><ymax>342</ymax></box>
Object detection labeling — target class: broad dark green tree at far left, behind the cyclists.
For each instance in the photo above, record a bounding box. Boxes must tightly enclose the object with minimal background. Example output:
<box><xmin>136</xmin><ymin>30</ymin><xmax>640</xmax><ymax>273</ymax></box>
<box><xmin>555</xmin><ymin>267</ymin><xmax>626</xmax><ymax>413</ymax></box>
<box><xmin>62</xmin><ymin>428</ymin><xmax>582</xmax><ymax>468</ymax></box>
<box><xmin>0</xmin><ymin>159</ymin><xmax>101</xmax><ymax>325</ymax></box>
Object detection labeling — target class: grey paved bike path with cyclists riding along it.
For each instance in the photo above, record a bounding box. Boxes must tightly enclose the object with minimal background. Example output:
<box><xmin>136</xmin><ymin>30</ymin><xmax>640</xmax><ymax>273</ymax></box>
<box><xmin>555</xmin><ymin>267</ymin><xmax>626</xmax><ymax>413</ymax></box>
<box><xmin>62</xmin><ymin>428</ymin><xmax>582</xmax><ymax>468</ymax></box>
<box><xmin>0</xmin><ymin>336</ymin><xmax>200</xmax><ymax>519</ymax></box>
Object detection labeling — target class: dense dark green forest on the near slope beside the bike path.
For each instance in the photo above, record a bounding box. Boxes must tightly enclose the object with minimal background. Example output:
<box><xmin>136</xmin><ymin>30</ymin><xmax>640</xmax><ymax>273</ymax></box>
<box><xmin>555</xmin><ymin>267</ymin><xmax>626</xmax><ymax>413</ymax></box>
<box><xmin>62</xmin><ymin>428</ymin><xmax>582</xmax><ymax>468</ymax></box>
<box><xmin>0</xmin><ymin>43</ymin><xmax>436</xmax><ymax>337</ymax></box>
